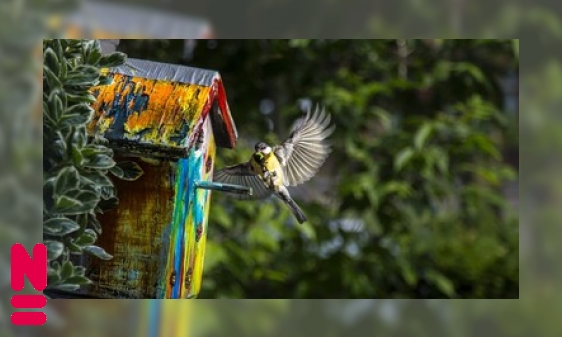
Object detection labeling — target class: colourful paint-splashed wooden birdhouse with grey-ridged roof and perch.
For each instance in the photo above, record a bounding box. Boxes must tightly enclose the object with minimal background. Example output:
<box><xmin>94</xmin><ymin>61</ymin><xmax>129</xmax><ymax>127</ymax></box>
<box><xmin>66</xmin><ymin>59</ymin><xmax>246</xmax><ymax>298</ymax></box>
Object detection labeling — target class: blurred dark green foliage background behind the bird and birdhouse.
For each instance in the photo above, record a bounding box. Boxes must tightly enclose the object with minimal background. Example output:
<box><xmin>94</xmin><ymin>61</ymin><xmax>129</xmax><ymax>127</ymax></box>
<box><xmin>118</xmin><ymin>40</ymin><xmax>519</xmax><ymax>298</ymax></box>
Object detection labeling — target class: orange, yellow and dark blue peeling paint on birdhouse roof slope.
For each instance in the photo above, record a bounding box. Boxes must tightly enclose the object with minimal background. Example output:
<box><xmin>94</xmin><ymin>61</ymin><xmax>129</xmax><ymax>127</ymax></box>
<box><xmin>90</xmin><ymin>74</ymin><xmax>211</xmax><ymax>148</ymax></box>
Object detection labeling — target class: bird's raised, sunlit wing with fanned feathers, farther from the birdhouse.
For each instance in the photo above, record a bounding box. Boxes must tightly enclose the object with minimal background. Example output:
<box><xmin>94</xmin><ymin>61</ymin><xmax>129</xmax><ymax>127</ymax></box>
<box><xmin>273</xmin><ymin>107</ymin><xmax>335</xmax><ymax>186</ymax></box>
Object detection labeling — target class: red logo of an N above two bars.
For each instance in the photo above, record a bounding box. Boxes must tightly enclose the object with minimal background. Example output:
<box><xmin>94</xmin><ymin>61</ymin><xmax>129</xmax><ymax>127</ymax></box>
<box><xmin>10</xmin><ymin>243</ymin><xmax>47</xmax><ymax>325</ymax></box>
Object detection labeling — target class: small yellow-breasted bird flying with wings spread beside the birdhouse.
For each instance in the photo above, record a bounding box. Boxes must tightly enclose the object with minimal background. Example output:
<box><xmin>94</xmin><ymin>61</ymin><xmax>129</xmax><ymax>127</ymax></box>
<box><xmin>210</xmin><ymin>107</ymin><xmax>335</xmax><ymax>224</ymax></box>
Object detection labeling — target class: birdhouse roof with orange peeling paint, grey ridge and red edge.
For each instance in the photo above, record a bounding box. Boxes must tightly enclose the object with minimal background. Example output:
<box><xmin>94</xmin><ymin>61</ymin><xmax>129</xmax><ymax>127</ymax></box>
<box><xmin>89</xmin><ymin>59</ymin><xmax>238</xmax><ymax>157</ymax></box>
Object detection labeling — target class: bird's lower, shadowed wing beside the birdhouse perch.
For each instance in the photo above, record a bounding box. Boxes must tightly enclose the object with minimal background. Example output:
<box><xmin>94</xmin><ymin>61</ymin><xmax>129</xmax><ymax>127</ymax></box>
<box><xmin>213</xmin><ymin>163</ymin><xmax>271</xmax><ymax>200</ymax></box>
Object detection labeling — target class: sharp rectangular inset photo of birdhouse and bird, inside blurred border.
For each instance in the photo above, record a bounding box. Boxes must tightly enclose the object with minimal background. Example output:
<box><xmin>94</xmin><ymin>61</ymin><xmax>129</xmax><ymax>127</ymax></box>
<box><xmin>43</xmin><ymin>39</ymin><xmax>519</xmax><ymax>299</ymax></box>
